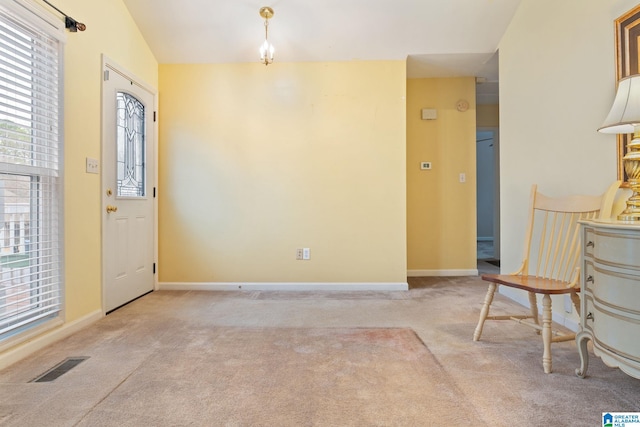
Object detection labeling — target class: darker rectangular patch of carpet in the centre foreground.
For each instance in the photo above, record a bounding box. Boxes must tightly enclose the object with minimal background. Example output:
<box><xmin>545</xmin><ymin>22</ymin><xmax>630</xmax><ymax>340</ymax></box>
<box><xmin>84</xmin><ymin>328</ymin><xmax>477</xmax><ymax>426</ymax></box>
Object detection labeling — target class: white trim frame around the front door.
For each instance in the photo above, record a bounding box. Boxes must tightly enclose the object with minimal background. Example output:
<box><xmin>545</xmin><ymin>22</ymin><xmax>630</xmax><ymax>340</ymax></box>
<box><xmin>99</xmin><ymin>54</ymin><xmax>159</xmax><ymax>315</ymax></box>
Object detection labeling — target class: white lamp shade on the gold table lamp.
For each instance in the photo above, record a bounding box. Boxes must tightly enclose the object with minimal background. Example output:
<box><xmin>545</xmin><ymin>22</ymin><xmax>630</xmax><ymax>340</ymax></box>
<box><xmin>598</xmin><ymin>74</ymin><xmax>640</xmax><ymax>133</ymax></box>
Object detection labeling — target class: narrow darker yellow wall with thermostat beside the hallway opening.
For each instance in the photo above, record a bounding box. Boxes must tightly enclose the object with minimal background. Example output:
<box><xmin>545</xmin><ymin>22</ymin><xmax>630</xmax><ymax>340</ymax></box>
<box><xmin>407</xmin><ymin>77</ymin><xmax>476</xmax><ymax>275</ymax></box>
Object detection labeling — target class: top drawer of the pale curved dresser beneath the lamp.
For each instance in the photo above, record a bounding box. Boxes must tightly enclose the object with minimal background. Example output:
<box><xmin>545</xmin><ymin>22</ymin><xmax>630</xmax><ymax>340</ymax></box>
<box><xmin>593</xmin><ymin>230</ymin><xmax>640</xmax><ymax>271</ymax></box>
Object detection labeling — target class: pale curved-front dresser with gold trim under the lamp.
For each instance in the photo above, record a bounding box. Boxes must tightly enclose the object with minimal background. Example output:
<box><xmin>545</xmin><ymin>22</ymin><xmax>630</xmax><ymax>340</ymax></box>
<box><xmin>576</xmin><ymin>220</ymin><xmax>640</xmax><ymax>378</ymax></box>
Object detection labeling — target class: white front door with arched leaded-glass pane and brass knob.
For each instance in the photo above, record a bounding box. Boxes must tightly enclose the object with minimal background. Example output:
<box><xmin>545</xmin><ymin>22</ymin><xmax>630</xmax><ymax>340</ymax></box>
<box><xmin>102</xmin><ymin>61</ymin><xmax>155</xmax><ymax>312</ymax></box>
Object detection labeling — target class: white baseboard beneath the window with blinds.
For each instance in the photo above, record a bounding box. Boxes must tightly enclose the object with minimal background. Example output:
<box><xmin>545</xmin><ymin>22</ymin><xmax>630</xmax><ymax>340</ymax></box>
<box><xmin>0</xmin><ymin>310</ymin><xmax>104</xmax><ymax>369</ymax></box>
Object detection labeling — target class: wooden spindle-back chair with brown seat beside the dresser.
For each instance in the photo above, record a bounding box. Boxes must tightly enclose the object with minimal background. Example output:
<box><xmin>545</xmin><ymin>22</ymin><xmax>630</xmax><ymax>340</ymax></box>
<box><xmin>473</xmin><ymin>181</ymin><xmax>620</xmax><ymax>373</ymax></box>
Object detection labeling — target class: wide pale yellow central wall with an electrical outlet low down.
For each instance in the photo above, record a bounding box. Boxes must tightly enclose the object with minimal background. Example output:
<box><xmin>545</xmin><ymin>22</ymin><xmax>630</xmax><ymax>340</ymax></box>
<box><xmin>159</xmin><ymin>61</ymin><xmax>406</xmax><ymax>283</ymax></box>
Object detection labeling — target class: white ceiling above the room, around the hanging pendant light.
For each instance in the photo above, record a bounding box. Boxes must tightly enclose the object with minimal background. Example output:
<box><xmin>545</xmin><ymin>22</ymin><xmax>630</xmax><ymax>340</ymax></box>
<box><xmin>122</xmin><ymin>0</ymin><xmax>521</xmax><ymax>102</ymax></box>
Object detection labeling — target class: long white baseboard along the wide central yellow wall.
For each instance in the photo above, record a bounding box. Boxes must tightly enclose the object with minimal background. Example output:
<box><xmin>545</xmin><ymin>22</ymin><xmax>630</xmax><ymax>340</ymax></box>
<box><xmin>158</xmin><ymin>282</ymin><xmax>409</xmax><ymax>291</ymax></box>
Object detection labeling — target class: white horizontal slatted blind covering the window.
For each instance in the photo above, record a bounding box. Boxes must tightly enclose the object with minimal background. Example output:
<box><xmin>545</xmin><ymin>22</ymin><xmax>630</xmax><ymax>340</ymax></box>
<box><xmin>0</xmin><ymin>0</ymin><xmax>63</xmax><ymax>340</ymax></box>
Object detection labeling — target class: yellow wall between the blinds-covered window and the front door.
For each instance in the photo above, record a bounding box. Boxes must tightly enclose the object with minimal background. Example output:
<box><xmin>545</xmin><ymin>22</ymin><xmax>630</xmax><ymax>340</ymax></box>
<box><xmin>56</xmin><ymin>0</ymin><xmax>158</xmax><ymax>321</ymax></box>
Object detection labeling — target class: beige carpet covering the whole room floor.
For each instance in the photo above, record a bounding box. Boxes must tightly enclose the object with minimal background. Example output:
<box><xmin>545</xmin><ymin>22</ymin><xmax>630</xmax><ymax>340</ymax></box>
<box><xmin>0</xmin><ymin>266</ymin><xmax>640</xmax><ymax>427</ymax></box>
